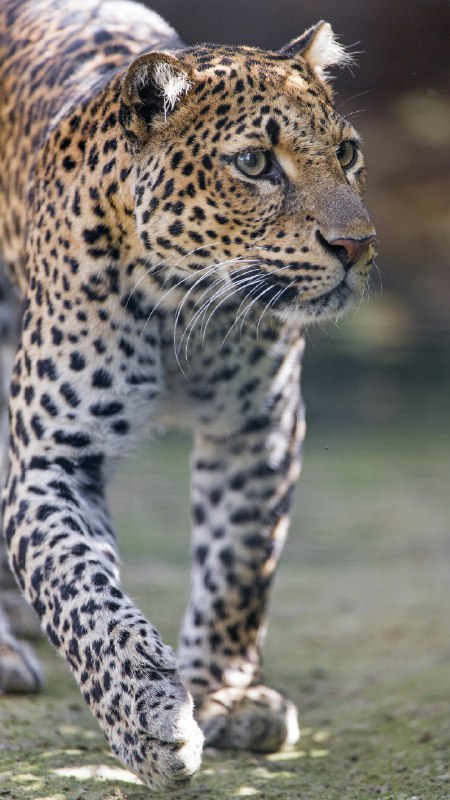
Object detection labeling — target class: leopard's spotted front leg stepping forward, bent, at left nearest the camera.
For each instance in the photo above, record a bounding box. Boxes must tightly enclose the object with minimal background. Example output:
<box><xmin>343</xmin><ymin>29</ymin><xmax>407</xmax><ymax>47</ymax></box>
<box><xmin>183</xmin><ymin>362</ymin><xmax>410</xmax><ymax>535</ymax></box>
<box><xmin>4</xmin><ymin>338</ymin><xmax>203</xmax><ymax>788</ymax></box>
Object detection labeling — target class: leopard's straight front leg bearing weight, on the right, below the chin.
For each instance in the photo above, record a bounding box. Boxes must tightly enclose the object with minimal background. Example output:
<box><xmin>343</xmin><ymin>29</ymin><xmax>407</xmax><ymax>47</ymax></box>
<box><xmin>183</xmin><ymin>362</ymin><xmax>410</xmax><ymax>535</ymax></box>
<box><xmin>179</xmin><ymin>328</ymin><xmax>304</xmax><ymax>751</ymax></box>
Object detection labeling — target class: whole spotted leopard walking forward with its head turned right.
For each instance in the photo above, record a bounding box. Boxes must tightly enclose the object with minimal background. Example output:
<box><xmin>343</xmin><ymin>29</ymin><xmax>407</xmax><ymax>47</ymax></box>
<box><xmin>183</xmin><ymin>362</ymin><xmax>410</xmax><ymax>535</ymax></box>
<box><xmin>0</xmin><ymin>0</ymin><xmax>376</xmax><ymax>789</ymax></box>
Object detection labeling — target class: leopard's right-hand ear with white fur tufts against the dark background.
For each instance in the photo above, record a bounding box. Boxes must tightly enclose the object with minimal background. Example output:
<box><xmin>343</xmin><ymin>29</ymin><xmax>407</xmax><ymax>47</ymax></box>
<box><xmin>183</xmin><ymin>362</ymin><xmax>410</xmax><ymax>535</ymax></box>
<box><xmin>279</xmin><ymin>20</ymin><xmax>353</xmax><ymax>79</ymax></box>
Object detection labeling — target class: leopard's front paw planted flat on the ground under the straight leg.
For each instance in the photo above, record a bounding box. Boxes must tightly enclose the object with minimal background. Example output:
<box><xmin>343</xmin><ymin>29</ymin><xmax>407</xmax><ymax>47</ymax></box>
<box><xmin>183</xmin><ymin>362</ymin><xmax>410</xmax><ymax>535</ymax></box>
<box><xmin>195</xmin><ymin>686</ymin><xmax>300</xmax><ymax>753</ymax></box>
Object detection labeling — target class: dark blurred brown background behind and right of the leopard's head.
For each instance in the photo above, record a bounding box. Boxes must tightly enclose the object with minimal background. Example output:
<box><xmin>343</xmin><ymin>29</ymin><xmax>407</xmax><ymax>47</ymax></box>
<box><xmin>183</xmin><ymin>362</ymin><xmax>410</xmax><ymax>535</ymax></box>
<box><xmin>149</xmin><ymin>0</ymin><xmax>450</xmax><ymax>427</ymax></box>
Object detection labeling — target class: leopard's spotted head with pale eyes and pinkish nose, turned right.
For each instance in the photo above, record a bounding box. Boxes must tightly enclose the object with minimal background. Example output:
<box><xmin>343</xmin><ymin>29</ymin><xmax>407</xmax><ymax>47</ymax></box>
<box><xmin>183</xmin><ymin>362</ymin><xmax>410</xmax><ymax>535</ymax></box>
<box><xmin>122</xmin><ymin>29</ymin><xmax>375</xmax><ymax>322</ymax></box>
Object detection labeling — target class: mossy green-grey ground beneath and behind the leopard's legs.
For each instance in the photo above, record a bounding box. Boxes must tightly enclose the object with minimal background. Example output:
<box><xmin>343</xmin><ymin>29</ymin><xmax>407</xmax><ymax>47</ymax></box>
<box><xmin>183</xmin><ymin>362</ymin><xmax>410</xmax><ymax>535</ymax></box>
<box><xmin>0</xmin><ymin>425</ymin><xmax>450</xmax><ymax>800</ymax></box>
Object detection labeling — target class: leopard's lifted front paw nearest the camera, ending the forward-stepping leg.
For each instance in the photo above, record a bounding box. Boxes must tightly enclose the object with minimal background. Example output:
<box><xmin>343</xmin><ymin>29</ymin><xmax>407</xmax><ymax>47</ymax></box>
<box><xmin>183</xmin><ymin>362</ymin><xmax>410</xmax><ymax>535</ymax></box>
<box><xmin>87</xmin><ymin>632</ymin><xmax>204</xmax><ymax>790</ymax></box>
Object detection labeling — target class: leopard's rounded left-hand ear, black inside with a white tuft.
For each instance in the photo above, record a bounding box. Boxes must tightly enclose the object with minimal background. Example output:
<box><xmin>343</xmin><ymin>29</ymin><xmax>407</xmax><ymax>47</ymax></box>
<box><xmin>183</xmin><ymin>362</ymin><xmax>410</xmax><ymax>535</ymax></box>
<box><xmin>120</xmin><ymin>53</ymin><xmax>192</xmax><ymax>143</ymax></box>
